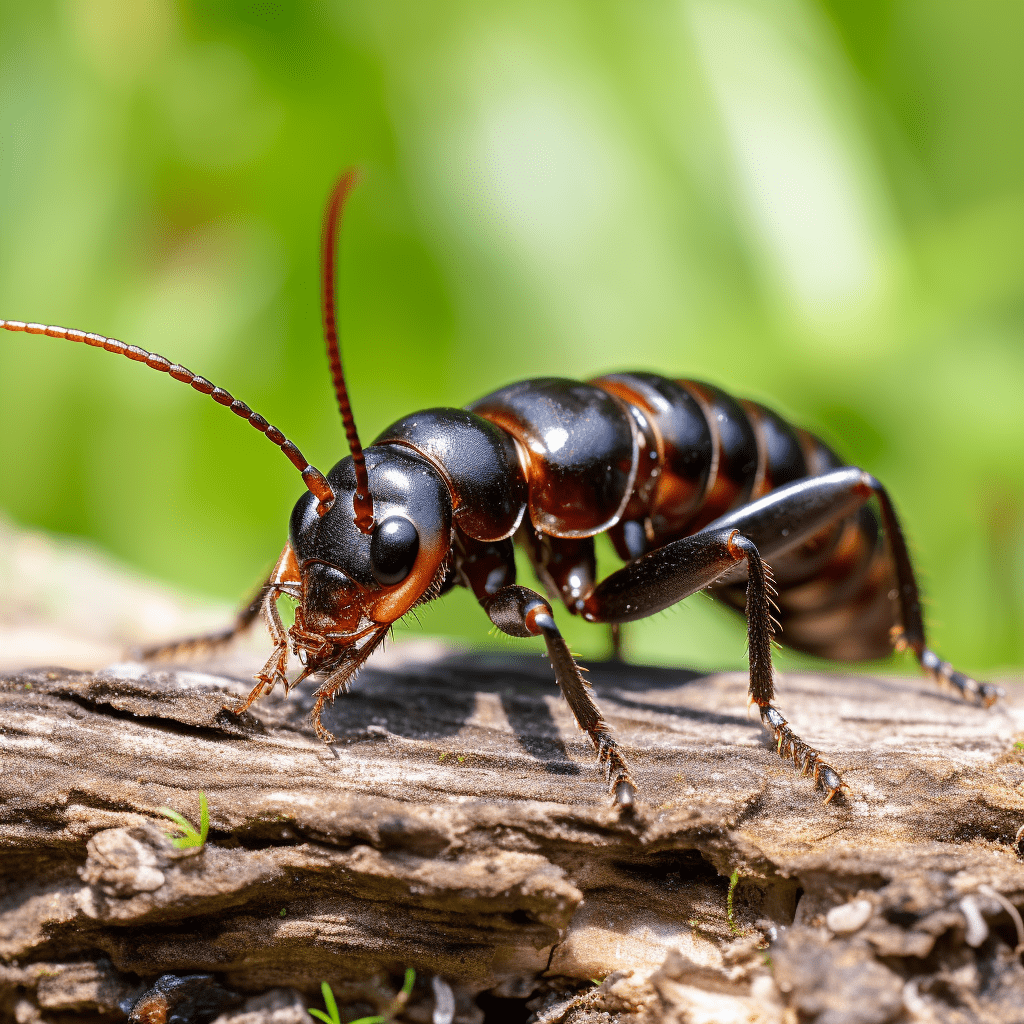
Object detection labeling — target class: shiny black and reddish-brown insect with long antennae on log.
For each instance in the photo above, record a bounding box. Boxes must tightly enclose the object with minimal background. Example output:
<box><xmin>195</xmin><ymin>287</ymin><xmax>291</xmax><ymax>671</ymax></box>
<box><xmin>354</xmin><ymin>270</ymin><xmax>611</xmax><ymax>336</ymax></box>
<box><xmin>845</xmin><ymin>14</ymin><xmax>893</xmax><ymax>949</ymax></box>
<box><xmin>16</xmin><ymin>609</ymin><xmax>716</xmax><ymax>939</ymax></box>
<box><xmin>0</xmin><ymin>171</ymin><xmax>1001</xmax><ymax>808</ymax></box>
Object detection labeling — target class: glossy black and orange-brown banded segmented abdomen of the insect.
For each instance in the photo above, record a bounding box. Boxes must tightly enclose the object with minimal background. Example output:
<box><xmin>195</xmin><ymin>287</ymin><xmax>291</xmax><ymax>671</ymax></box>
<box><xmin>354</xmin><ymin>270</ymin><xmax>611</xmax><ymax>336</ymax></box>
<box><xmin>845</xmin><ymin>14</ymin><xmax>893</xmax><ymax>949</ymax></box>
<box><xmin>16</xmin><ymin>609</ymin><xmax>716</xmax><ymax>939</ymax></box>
<box><xmin>469</xmin><ymin>373</ymin><xmax>897</xmax><ymax>660</ymax></box>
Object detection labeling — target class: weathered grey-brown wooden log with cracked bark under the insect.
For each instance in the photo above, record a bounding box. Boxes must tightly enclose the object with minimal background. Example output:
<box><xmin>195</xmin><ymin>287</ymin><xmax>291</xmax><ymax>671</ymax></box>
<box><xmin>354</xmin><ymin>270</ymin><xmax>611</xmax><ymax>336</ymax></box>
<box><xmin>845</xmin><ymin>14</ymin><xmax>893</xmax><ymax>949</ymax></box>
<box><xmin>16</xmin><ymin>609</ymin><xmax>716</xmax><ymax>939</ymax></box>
<box><xmin>0</xmin><ymin>643</ymin><xmax>1024</xmax><ymax>1022</ymax></box>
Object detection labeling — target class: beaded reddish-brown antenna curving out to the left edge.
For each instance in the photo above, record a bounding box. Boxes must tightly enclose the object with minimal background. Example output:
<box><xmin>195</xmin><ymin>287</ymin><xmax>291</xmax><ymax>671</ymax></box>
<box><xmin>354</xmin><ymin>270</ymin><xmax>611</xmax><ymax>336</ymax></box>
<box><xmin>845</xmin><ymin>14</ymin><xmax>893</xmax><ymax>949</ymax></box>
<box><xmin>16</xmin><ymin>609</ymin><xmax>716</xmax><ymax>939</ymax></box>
<box><xmin>0</xmin><ymin>319</ymin><xmax>334</xmax><ymax>516</ymax></box>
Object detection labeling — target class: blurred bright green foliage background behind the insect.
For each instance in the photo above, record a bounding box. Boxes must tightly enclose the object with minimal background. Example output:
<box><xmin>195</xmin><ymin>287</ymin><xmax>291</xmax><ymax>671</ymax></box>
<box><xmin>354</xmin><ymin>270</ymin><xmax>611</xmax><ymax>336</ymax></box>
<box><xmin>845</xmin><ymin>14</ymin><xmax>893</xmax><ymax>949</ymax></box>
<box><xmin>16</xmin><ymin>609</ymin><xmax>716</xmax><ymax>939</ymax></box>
<box><xmin>0</xmin><ymin>0</ymin><xmax>1024</xmax><ymax>675</ymax></box>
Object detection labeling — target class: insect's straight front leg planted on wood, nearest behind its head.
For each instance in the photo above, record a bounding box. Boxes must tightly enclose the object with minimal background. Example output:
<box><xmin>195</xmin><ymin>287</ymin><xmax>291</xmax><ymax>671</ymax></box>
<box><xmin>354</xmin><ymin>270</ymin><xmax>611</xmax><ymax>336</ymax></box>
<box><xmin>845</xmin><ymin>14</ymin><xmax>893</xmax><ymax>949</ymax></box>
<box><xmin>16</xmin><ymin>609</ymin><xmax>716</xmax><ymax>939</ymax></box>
<box><xmin>484</xmin><ymin>585</ymin><xmax>636</xmax><ymax>807</ymax></box>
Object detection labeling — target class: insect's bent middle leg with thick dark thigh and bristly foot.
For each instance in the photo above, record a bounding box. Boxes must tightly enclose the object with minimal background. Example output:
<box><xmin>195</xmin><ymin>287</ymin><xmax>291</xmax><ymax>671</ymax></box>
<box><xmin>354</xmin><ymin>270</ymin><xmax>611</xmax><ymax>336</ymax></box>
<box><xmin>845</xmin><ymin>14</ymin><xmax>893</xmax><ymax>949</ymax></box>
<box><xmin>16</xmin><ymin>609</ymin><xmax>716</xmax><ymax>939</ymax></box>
<box><xmin>584</xmin><ymin>526</ymin><xmax>843</xmax><ymax>803</ymax></box>
